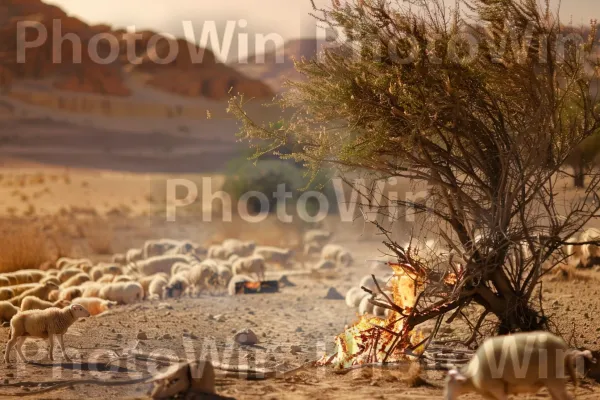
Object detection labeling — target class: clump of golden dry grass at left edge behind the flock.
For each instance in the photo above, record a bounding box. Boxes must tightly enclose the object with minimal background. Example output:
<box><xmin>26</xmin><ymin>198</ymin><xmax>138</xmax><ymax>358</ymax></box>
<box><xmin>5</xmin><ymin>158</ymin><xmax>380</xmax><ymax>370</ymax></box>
<box><xmin>0</xmin><ymin>227</ymin><xmax>52</xmax><ymax>272</ymax></box>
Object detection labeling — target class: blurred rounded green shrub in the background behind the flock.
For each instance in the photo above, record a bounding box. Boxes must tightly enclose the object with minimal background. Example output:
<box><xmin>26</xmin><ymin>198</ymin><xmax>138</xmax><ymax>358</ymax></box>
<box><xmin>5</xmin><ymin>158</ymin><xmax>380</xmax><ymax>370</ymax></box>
<box><xmin>223</xmin><ymin>160</ymin><xmax>337</xmax><ymax>216</ymax></box>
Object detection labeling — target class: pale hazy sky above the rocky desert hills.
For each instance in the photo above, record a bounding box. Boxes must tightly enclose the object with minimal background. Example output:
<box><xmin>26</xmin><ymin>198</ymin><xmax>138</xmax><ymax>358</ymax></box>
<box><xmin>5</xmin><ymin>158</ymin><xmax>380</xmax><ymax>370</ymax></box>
<box><xmin>45</xmin><ymin>0</ymin><xmax>600</xmax><ymax>59</ymax></box>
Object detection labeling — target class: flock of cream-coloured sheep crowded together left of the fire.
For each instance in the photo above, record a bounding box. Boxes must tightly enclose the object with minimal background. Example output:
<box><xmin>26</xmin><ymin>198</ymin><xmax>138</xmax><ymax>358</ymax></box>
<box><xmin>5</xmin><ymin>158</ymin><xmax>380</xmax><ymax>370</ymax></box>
<box><xmin>0</xmin><ymin>230</ymin><xmax>353</xmax><ymax>362</ymax></box>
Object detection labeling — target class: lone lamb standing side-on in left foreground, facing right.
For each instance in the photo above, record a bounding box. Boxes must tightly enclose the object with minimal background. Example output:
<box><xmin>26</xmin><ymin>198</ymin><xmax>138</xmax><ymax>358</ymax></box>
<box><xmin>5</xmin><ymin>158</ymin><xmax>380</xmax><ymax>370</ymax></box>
<box><xmin>4</xmin><ymin>304</ymin><xmax>90</xmax><ymax>363</ymax></box>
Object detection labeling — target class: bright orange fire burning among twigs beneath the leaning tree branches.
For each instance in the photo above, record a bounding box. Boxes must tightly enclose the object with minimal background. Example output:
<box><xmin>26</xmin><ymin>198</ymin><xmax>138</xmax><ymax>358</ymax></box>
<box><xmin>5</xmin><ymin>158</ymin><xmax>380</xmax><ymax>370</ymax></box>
<box><xmin>318</xmin><ymin>263</ymin><xmax>425</xmax><ymax>369</ymax></box>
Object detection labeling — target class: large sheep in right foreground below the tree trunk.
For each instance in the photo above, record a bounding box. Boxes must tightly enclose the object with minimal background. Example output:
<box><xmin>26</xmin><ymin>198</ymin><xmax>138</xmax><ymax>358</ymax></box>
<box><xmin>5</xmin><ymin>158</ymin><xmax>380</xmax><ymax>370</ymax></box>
<box><xmin>445</xmin><ymin>332</ymin><xmax>593</xmax><ymax>400</ymax></box>
